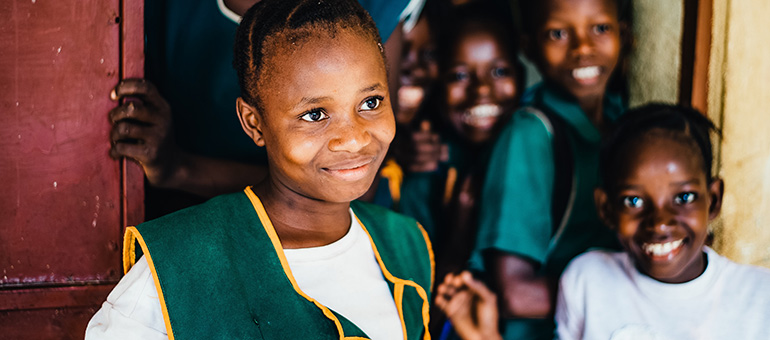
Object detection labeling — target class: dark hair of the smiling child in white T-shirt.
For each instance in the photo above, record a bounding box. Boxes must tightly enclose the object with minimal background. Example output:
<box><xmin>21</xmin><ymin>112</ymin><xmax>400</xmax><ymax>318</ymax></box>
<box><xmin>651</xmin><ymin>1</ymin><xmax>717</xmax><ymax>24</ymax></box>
<box><xmin>599</xmin><ymin>103</ymin><xmax>721</xmax><ymax>189</ymax></box>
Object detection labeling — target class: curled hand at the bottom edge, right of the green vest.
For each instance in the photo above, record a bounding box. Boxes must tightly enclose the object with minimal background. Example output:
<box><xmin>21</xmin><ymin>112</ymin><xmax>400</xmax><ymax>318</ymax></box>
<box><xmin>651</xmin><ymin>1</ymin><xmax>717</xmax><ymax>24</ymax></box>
<box><xmin>436</xmin><ymin>271</ymin><xmax>502</xmax><ymax>340</ymax></box>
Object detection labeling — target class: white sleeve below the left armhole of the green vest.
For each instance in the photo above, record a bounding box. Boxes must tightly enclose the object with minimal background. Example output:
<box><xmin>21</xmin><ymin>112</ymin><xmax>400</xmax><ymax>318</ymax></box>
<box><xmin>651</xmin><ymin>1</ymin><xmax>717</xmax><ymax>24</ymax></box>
<box><xmin>85</xmin><ymin>257</ymin><xmax>168</xmax><ymax>340</ymax></box>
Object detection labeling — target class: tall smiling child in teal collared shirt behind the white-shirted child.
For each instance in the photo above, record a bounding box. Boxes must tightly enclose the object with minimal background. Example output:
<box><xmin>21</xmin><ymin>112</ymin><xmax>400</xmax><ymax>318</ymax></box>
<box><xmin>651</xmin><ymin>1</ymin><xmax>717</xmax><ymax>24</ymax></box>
<box><xmin>462</xmin><ymin>0</ymin><xmax>626</xmax><ymax>339</ymax></box>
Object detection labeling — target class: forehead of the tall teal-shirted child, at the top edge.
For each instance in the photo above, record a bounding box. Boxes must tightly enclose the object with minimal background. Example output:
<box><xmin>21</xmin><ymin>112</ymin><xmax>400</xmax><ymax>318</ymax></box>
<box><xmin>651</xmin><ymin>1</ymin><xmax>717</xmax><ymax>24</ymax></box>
<box><xmin>538</xmin><ymin>0</ymin><xmax>618</xmax><ymax>24</ymax></box>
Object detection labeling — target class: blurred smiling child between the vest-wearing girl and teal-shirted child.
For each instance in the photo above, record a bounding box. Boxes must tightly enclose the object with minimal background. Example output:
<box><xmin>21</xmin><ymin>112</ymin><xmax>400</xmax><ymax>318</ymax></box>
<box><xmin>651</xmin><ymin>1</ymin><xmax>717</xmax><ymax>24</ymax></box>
<box><xmin>399</xmin><ymin>3</ymin><xmax>522</xmax><ymax>266</ymax></box>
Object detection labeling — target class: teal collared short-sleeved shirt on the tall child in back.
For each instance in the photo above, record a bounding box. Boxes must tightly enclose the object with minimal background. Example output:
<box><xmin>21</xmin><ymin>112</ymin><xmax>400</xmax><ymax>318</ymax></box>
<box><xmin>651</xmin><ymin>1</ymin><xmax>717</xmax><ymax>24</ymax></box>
<box><xmin>474</xmin><ymin>84</ymin><xmax>624</xmax><ymax>339</ymax></box>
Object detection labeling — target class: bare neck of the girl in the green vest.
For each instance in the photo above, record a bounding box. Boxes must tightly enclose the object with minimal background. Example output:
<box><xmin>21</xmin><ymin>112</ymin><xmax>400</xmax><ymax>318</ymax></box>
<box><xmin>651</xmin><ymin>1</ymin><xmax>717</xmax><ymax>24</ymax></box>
<box><xmin>253</xmin><ymin>176</ymin><xmax>351</xmax><ymax>249</ymax></box>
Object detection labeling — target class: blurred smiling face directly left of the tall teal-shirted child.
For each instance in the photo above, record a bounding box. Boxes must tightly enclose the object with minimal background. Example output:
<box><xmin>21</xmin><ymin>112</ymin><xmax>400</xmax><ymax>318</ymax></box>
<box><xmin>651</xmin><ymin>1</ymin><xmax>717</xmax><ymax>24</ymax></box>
<box><xmin>444</xmin><ymin>28</ymin><xmax>519</xmax><ymax>143</ymax></box>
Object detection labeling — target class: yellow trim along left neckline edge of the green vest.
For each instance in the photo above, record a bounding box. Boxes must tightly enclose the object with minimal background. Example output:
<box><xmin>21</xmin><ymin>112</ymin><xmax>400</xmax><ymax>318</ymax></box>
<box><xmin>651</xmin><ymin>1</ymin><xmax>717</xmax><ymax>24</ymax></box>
<box><xmin>243</xmin><ymin>187</ymin><xmax>368</xmax><ymax>340</ymax></box>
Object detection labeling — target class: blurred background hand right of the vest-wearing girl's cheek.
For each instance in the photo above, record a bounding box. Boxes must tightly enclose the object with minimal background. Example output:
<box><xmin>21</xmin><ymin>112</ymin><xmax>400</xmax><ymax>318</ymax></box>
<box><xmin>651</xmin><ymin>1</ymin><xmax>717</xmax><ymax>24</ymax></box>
<box><xmin>408</xmin><ymin>121</ymin><xmax>449</xmax><ymax>172</ymax></box>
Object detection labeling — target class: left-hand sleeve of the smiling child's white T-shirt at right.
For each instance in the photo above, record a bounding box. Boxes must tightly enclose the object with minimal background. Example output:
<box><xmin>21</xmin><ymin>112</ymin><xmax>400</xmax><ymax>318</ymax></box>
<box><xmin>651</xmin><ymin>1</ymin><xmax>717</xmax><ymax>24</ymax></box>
<box><xmin>555</xmin><ymin>266</ymin><xmax>585</xmax><ymax>340</ymax></box>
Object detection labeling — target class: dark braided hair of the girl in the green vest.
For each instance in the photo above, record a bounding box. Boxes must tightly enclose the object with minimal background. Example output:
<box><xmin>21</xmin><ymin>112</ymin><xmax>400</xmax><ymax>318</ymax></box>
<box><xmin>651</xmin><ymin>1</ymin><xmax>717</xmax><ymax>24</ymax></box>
<box><xmin>233</xmin><ymin>0</ymin><xmax>384</xmax><ymax>110</ymax></box>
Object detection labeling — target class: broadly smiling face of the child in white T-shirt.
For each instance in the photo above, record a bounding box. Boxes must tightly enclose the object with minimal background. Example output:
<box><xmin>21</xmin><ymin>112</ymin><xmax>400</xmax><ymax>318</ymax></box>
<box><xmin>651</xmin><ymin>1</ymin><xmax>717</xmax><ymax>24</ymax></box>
<box><xmin>596</xmin><ymin>130</ymin><xmax>723</xmax><ymax>283</ymax></box>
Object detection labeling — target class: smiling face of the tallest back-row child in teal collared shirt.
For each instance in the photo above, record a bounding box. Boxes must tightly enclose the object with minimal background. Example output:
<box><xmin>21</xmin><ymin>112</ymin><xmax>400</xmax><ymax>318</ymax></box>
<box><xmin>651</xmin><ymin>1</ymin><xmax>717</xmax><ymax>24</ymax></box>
<box><xmin>529</xmin><ymin>0</ymin><xmax>621</xmax><ymax>99</ymax></box>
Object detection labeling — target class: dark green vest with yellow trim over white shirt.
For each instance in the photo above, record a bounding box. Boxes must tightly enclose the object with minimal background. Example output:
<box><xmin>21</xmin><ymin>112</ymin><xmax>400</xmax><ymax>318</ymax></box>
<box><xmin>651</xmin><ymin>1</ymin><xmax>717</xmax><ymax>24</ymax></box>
<box><xmin>123</xmin><ymin>188</ymin><xmax>433</xmax><ymax>340</ymax></box>
